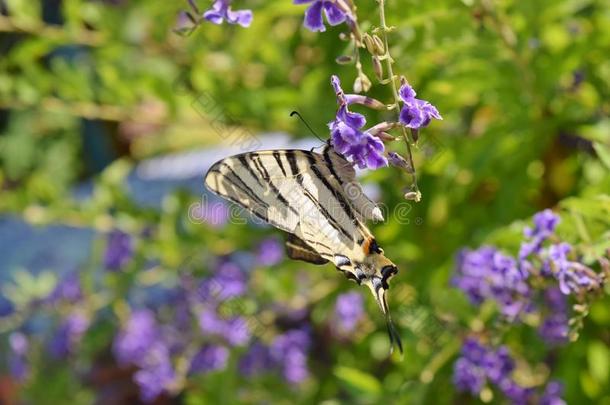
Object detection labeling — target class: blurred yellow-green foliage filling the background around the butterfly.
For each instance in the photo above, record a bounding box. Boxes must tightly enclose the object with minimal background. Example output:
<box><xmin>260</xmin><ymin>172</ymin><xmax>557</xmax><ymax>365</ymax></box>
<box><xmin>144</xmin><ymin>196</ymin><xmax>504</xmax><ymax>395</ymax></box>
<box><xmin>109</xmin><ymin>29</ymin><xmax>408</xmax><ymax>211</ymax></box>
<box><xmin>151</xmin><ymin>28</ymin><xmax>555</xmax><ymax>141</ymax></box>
<box><xmin>0</xmin><ymin>0</ymin><xmax>610</xmax><ymax>405</ymax></box>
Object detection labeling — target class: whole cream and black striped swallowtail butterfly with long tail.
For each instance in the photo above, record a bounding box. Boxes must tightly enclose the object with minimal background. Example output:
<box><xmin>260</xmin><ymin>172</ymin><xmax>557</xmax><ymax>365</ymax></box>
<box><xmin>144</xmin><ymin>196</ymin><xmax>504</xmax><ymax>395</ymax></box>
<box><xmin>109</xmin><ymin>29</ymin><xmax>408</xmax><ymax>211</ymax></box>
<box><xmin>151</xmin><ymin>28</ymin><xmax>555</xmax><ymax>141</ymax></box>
<box><xmin>205</xmin><ymin>144</ymin><xmax>402</xmax><ymax>353</ymax></box>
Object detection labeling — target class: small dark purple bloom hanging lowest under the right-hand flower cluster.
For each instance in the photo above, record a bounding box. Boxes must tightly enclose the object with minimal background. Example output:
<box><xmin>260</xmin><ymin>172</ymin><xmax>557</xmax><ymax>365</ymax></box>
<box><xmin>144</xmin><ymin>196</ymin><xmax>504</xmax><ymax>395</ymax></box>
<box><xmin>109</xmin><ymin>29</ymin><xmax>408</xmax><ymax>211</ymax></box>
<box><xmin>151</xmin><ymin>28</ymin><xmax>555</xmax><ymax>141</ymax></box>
<box><xmin>538</xmin><ymin>288</ymin><xmax>570</xmax><ymax>345</ymax></box>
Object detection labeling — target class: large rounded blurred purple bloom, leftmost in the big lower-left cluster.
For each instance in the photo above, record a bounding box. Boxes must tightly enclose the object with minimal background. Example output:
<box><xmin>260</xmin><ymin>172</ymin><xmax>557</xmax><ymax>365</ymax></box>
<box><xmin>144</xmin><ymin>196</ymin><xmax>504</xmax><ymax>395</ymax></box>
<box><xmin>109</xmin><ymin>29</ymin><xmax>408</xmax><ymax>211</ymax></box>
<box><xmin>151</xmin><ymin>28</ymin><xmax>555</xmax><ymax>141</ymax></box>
<box><xmin>113</xmin><ymin>309</ymin><xmax>159</xmax><ymax>366</ymax></box>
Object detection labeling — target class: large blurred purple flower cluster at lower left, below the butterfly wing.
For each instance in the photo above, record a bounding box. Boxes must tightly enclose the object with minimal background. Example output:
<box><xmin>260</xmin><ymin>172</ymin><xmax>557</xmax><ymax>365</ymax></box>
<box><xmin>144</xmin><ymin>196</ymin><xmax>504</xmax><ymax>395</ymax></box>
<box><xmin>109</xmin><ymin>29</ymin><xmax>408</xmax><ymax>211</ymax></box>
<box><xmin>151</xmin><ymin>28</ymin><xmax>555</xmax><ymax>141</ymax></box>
<box><xmin>113</xmin><ymin>261</ymin><xmax>250</xmax><ymax>402</ymax></box>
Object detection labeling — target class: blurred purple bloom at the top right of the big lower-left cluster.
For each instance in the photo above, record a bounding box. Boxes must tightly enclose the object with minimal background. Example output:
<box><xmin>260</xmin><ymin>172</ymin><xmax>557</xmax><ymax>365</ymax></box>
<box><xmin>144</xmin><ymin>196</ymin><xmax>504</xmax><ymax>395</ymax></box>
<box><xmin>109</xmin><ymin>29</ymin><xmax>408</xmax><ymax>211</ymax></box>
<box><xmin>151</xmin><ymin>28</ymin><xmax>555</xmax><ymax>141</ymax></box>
<box><xmin>197</xmin><ymin>261</ymin><xmax>246</xmax><ymax>303</ymax></box>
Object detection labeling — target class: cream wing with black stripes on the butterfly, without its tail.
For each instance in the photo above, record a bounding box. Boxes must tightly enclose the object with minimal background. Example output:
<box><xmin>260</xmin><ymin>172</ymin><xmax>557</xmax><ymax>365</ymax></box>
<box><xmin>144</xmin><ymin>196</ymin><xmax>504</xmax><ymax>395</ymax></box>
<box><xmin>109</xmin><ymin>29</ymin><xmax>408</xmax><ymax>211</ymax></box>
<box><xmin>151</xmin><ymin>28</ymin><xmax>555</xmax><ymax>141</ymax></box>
<box><xmin>205</xmin><ymin>148</ymin><xmax>375</xmax><ymax>260</ymax></box>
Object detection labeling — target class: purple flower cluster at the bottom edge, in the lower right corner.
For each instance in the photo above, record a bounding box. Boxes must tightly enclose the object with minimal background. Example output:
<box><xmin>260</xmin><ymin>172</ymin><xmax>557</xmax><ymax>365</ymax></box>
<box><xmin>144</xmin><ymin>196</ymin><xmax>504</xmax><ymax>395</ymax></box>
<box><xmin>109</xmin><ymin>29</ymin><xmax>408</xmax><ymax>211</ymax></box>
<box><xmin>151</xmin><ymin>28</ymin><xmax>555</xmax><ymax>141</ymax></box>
<box><xmin>453</xmin><ymin>338</ymin><xmax>563</xmax><ymax>405</ymax></box>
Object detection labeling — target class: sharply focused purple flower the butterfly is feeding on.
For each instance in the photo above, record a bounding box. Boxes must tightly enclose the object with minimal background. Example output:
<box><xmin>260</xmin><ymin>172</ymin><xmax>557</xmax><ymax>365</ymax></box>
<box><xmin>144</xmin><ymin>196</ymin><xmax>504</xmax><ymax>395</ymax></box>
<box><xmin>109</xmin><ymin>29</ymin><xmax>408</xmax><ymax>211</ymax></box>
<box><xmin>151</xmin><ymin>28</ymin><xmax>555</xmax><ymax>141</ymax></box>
<box><xmin>328</xmin><ymin>76</ymin><xmax>388</xmax><ymax>169</ymax></box>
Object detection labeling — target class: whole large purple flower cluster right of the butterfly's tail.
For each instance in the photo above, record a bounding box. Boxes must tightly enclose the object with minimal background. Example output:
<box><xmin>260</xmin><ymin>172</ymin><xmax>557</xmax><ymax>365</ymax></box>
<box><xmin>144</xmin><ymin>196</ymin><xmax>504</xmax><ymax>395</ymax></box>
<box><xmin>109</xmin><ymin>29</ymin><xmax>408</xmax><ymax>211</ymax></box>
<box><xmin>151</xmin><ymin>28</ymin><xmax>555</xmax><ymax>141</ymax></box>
<box><xmin>453</xmin><ymin>210</ymin><xmax>603</xmax><ymax>344</ymax></box>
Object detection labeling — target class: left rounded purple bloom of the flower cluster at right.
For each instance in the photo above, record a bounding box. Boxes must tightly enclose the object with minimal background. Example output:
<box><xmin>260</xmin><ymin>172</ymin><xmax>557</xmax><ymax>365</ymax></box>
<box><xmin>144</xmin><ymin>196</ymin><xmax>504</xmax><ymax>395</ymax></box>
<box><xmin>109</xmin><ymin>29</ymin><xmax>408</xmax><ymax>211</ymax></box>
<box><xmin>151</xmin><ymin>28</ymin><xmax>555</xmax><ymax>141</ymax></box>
<box><xmin>453</xmin><ymin>246</ymin><xmax>530</xmax><ymax>320</ymax></box>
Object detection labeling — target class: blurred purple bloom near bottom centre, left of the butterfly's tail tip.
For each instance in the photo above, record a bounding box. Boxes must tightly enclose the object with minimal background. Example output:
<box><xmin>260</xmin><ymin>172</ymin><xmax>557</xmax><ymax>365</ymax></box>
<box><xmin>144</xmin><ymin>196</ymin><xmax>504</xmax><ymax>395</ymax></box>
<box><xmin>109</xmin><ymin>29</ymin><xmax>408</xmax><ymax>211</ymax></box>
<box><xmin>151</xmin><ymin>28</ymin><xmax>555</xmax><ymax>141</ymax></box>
<box><xmin>271</xmin><ymin>329</ymin><xmax>311</xmax><ymax>384</ymax></box>
